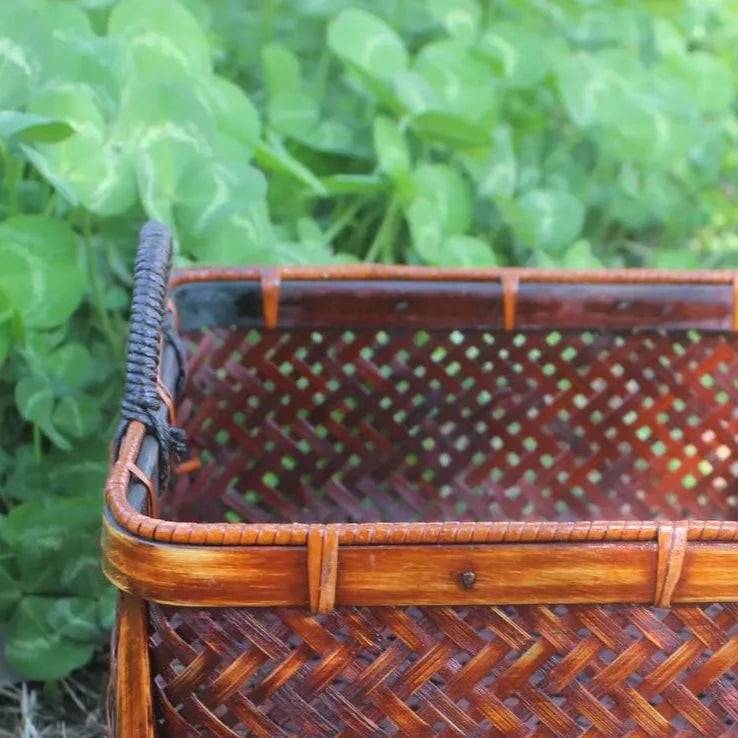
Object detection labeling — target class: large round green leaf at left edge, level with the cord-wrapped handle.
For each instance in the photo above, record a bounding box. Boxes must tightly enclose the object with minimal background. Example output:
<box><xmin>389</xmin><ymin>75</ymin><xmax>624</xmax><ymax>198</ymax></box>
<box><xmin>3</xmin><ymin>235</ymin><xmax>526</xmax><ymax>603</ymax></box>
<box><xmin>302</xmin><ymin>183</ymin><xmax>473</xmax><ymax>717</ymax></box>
<box><xmin>0</xmin><ymin>215</ymin><xmax>85</xmax><ymax>328</ymax></box>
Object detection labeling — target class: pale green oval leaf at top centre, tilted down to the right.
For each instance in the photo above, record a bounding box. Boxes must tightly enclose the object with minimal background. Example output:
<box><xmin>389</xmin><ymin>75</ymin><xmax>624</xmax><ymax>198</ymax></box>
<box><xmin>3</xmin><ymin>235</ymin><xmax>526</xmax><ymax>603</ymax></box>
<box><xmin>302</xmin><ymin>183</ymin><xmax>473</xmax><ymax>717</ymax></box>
<box><xmin>328</xmin><ymin>8</ymin><xmax>408</xmax><ymax>81</ymax></box>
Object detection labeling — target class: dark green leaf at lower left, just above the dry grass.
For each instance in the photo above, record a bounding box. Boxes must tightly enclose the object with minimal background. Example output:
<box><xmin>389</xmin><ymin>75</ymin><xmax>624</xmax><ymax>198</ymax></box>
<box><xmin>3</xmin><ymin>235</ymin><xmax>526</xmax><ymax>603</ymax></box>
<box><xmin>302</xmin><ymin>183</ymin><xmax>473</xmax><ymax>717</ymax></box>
<box><xmin>5</xmin><ymin>597</ymin><xmax>94</xmax><ymax>680</ymax></box>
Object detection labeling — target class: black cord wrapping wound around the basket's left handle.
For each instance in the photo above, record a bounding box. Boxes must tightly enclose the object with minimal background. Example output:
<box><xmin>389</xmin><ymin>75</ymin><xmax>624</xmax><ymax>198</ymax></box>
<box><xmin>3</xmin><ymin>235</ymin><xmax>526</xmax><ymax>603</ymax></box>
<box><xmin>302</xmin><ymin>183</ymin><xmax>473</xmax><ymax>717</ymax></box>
<box><xmin>115</xmin><ymin>221</ymin><xmax>187</xmax><ymax>485</ymax></box>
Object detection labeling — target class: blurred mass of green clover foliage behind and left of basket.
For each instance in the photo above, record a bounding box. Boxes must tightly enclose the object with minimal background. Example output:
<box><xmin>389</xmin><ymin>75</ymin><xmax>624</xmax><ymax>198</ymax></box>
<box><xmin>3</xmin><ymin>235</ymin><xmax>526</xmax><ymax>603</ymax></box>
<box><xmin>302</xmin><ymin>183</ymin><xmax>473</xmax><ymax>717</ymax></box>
<box><xmin>0</xmin><ymin>0</ymin><xmax>738</xmax><ymax>680</ymax></box>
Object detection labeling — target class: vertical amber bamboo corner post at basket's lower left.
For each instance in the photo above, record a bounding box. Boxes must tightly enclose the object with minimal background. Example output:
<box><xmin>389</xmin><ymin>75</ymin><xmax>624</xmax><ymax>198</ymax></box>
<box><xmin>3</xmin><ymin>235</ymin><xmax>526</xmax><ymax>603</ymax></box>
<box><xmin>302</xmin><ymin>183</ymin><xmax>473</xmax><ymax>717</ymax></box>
<box><xmin>111</xmin><ymin>593</ymin><xmax>155</xmax><ymax>738</ymax></box>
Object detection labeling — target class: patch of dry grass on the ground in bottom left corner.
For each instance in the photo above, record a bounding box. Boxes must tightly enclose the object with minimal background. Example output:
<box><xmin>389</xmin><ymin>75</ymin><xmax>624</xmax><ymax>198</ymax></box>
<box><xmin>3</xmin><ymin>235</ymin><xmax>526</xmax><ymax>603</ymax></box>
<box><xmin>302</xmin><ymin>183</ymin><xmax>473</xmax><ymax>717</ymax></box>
<box><xmin>0</xmin><ymin>659</ymin><xmax>107</xmax><ymax>738</ymax></box>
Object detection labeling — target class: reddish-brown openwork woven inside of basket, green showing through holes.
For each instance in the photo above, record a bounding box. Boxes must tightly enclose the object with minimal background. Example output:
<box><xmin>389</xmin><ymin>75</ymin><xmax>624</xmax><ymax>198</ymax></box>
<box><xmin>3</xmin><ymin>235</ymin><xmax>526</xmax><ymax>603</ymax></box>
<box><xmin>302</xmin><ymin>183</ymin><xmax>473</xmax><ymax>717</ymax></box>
<box><xmin>164</xmin><ymin>316</ymin><xmax>738</xmax><ymax>522</ymax></box>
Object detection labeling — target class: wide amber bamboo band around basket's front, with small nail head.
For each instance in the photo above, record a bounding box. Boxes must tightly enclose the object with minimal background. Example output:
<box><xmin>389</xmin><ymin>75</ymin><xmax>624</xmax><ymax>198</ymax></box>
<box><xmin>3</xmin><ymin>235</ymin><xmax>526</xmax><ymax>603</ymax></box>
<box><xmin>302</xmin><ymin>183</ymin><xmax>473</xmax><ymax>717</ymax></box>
<box><xmin>103</xmin><ymin>520</ymin><xmax>738</xmax><ymax>610</ymax></box>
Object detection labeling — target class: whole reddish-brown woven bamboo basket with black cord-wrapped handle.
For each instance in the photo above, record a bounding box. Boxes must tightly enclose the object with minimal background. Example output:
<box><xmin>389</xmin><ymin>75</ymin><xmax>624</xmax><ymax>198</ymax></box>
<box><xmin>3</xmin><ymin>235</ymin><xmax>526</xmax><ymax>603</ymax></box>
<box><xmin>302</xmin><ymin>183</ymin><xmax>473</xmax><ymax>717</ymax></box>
<box><xmin>104</xmin><ymin>224</ymin><xmax>738</xmax><ymax>738</ymax></box>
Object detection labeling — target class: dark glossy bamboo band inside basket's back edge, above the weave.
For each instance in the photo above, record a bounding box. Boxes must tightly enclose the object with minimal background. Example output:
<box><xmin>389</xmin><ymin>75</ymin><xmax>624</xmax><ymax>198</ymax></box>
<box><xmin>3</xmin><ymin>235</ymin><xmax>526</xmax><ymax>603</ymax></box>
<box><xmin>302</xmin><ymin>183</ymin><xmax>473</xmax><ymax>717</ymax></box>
<box><xmin>173</xmin><ymin>270</ymin><xmax>736</xmax><ymax>330</ymax></box>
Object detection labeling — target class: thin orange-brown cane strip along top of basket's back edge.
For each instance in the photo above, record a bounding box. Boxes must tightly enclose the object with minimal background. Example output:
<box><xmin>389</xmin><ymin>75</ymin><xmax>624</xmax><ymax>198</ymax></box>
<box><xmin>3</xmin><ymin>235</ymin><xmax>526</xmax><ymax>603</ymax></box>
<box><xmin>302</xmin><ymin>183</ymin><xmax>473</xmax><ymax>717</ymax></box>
<box><xmin>170</xmin><ymin>264</ymin><xmax>734</xmax><ymax>287</ymax></box>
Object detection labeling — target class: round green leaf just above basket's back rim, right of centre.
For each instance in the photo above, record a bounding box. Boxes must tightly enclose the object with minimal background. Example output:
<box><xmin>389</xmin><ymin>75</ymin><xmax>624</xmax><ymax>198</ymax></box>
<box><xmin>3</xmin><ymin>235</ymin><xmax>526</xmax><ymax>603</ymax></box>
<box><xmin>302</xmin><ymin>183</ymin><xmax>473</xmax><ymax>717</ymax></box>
<box><xmin>503</xmin><ymin>190</ymin><xmax>584</xmax><ymax>251</ymax></box>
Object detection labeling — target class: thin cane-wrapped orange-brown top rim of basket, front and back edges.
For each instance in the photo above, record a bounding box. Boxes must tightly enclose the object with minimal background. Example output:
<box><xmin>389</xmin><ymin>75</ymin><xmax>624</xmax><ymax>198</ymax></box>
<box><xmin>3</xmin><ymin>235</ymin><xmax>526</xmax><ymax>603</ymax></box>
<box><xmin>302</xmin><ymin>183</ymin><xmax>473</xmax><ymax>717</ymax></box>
<box><xmin>105</xmin><ymin>264</ymin><xmax>738</xmax><ymax>546</ymax></box>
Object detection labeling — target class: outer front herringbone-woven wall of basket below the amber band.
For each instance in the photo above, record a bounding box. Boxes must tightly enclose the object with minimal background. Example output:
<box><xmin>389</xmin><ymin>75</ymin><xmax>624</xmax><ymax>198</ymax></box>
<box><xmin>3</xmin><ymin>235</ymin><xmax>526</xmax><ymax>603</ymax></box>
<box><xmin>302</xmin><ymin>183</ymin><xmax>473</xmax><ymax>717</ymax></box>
<box><xmin>151</xmin><ymin>605</ymin><xmax>738</xmax><ymax>738</ymax></box>
